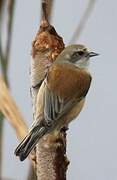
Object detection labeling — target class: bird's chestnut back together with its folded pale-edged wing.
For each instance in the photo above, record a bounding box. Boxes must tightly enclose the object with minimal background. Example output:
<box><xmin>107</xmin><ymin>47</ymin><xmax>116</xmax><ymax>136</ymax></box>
<box><xmin>44</xmin><ymin>62</ymin><xmax>91</xmax><ymax>126</ymax></box>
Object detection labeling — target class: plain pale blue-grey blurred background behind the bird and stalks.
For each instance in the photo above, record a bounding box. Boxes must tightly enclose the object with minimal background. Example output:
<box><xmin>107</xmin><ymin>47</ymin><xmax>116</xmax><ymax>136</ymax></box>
<box><xmin>0</xmin><ymin>0</ymin><xmax>117</xmax><ymax>180</ymax></box>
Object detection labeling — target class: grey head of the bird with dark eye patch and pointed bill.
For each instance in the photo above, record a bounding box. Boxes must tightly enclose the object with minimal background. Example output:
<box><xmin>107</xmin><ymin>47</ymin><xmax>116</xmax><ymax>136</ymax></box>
<box><xmin>56</xmin><ymin>44</ymin><xmax>98</xmax><ymax>68</ymax></box>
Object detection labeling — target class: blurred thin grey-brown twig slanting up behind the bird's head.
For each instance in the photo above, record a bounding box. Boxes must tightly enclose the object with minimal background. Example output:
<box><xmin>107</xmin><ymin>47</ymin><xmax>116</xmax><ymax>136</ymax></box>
<box><xmin>69</xmin><ymin>0</ymin><xmax>96</xmax><ymax>44</ymax></box>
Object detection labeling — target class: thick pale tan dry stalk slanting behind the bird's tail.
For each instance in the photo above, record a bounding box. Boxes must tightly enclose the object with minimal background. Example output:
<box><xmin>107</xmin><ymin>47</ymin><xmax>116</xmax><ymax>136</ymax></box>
<box><xmin>0</xmin><ymin>77</ymin><xmax>35</xmax><ymax>167</ymax></box>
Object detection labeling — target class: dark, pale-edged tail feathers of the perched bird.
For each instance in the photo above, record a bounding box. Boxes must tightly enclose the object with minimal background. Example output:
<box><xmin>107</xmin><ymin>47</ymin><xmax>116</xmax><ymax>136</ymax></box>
<box><xmin>15</xmin><ymin>121</ymin><xmax>47</xmax><ymax>161</ymax></box>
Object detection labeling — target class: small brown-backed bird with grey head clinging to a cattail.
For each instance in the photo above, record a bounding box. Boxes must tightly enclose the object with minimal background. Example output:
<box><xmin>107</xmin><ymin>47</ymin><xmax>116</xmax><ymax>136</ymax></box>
<box><xmin>15</xmin><ymin>44</ymin><xmax>99</xmax><ymax>161</ymax></box>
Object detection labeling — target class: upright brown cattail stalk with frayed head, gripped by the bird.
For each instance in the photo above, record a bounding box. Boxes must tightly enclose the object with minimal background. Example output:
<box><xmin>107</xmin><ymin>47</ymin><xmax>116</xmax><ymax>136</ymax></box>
<box><xmin>31</xmin><ymin>0</ymin><xmax>68</xmax><ymax>180</ymax></box>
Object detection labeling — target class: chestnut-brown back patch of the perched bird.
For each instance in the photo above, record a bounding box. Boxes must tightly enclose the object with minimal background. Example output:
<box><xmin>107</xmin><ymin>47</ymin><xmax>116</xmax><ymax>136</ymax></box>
<box><xmin>47</xmin><ymin>64</ymin><xmax>91</xmax><ymax>98</ymax></box>
